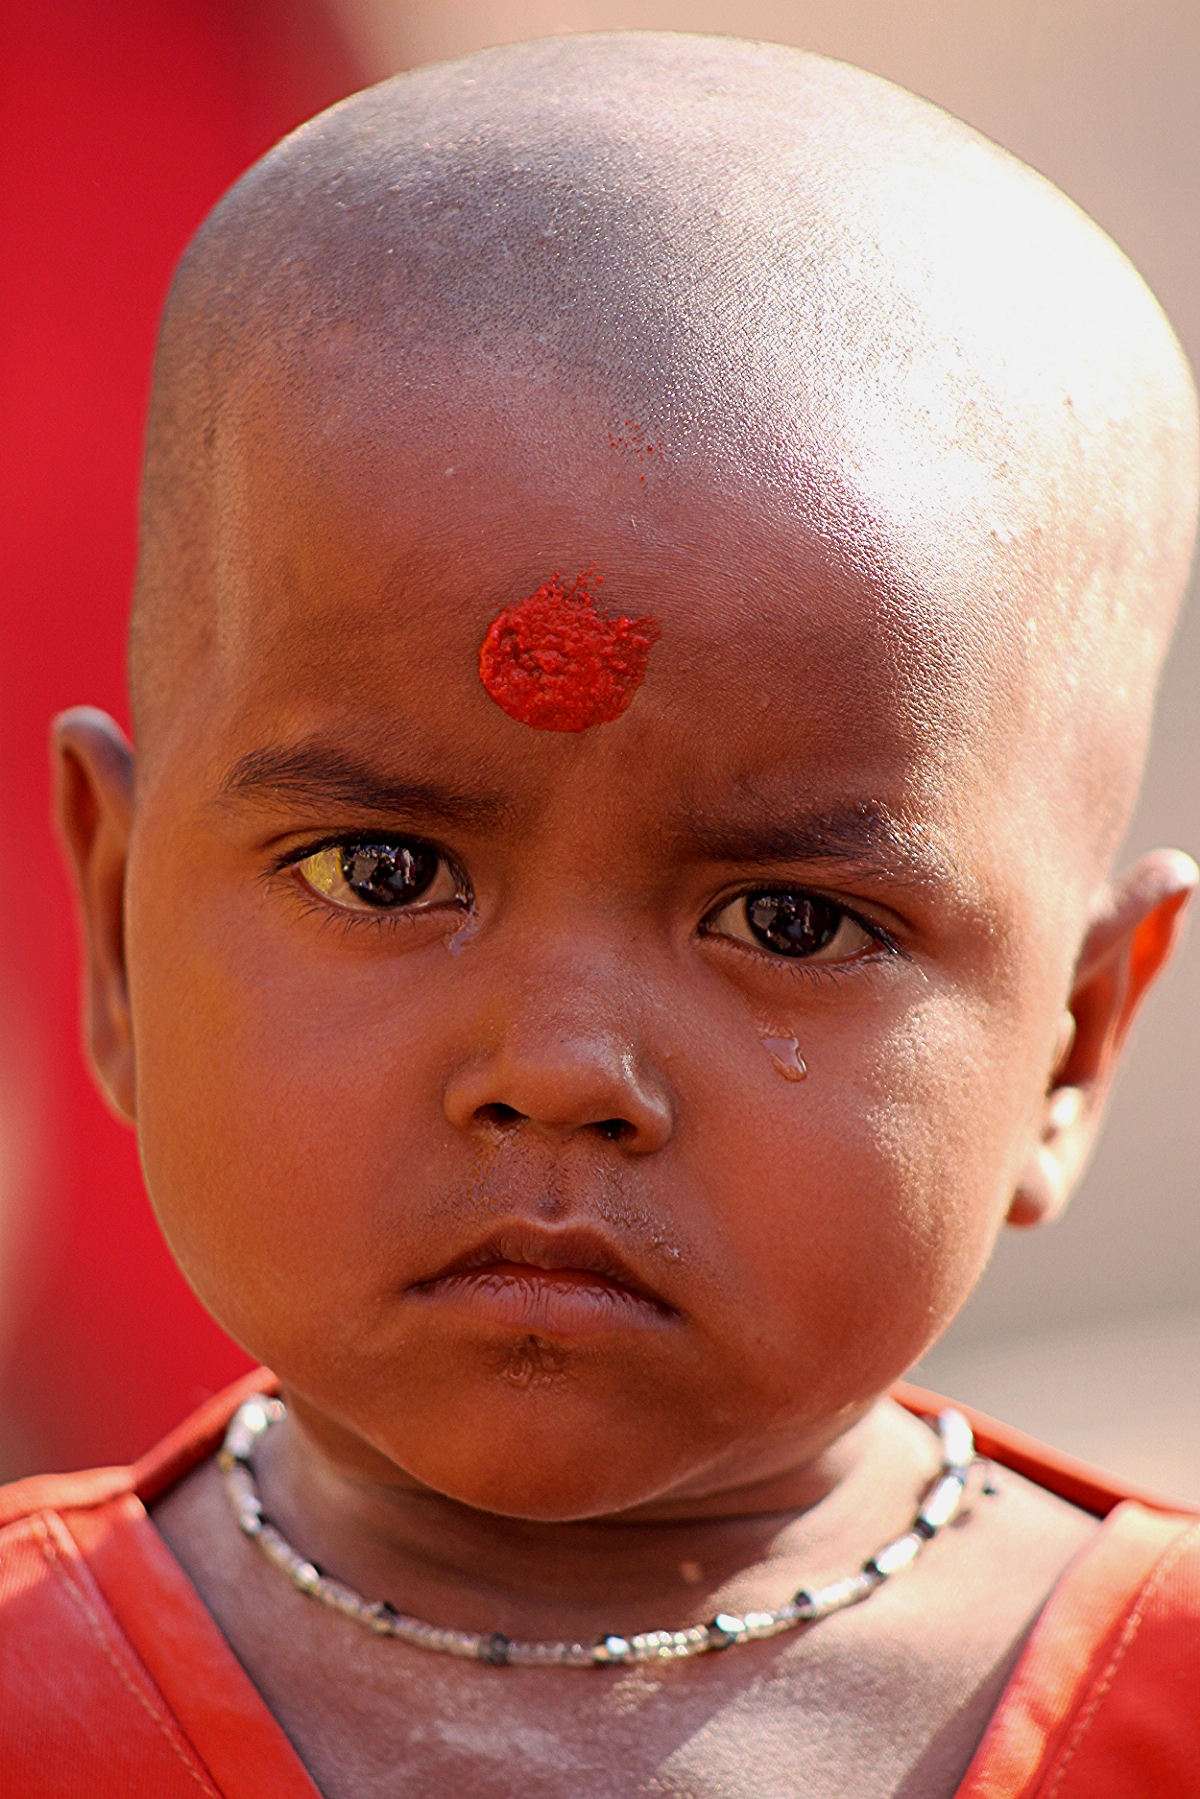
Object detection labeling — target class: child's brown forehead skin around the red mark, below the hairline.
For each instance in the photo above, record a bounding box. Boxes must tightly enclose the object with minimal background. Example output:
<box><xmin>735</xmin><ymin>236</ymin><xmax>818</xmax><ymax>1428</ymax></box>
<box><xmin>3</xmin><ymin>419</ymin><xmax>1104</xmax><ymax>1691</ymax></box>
<box><xmin>206</xmin><ymin>338</ymin><xmax>1027</xmax><ymax>787</ymax></box>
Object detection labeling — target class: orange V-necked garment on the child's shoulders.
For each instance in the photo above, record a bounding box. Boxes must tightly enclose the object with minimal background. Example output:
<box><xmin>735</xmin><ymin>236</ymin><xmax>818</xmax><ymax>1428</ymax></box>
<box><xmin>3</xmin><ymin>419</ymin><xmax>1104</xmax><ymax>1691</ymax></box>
<box><xmin>0</xmin><ymin>1369</ymin><xmax>1200</xmax><ymax>1799</ymax></box>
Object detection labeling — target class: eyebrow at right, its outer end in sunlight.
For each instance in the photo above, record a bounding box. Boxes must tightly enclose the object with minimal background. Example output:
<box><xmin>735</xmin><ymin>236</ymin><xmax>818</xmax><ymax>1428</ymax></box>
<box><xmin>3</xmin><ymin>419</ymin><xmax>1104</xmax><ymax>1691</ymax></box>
<box><xmin>685</xmin><ymin>801</ymin><xmax>948</xmax><ymax>885</ymax></box>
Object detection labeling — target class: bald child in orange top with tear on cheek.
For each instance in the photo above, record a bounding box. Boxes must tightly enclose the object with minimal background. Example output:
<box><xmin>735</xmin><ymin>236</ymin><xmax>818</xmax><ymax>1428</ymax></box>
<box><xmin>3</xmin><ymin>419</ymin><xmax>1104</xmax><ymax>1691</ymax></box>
<box><xmin>0</xmin><ymin>34</ymin><xmax>1200</xmax><ymax>1799</ymax></box>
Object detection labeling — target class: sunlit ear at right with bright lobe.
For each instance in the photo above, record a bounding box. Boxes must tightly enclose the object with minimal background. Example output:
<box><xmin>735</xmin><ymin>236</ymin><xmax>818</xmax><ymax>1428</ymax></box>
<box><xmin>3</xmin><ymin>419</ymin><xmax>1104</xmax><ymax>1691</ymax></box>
<box><xmin>1007</xmin><ymin>849</ymin><xmax>1200</xmax><ymax>1227</ymax></box>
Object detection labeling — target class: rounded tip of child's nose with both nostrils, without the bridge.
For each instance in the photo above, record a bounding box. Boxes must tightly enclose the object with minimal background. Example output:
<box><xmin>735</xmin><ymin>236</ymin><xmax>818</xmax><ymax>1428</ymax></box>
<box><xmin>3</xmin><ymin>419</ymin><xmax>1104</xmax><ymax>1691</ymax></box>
<box><xmin>444</xmin><ymin>1022</ymin><xmax>675</xmax><ymax>1155</ymax></box>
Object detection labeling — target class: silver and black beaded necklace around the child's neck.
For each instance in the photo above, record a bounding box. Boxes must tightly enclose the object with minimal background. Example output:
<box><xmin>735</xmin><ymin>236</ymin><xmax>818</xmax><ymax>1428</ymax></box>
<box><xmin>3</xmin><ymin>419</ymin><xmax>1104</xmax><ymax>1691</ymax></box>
<box><xmin>218</xmin><ymin>1392</ymin><xmax>975</xmax><ymax>1668</ymax></box>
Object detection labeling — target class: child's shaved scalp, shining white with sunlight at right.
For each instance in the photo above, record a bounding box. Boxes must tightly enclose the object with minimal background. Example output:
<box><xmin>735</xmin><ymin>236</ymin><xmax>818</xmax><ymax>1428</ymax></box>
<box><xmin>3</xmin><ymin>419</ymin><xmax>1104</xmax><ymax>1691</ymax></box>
<box><xmin>131</xmin><ymin>32</ymin><xmax>1196</xmax><ymax>856</ymax></box>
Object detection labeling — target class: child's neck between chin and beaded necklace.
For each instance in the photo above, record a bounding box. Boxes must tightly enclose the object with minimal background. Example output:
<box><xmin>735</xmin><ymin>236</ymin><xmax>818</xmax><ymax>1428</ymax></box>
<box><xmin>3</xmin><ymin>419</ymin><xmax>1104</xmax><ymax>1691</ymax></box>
<box><xmin>255</xmin><ymin>1401</ymin><xmax>937</xmax><ymax>1639</ymax></box>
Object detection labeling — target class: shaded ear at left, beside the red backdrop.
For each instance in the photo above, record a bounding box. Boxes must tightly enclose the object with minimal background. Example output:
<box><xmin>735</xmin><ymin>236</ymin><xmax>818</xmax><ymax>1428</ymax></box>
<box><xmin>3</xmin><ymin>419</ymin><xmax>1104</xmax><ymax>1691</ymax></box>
<box><xmin>52</xmin><ymin>705</ymin><xmax>133</xmax><ymax>1124</ymax></box>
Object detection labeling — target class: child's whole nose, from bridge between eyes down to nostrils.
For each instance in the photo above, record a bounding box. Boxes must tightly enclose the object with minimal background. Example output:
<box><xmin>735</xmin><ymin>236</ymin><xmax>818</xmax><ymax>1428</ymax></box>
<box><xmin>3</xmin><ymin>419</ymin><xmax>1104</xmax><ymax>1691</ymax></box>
<box><xmin>444</xmin><ymin>932</ymin><xmax>675</xmax><ymax>1153</ymax></box>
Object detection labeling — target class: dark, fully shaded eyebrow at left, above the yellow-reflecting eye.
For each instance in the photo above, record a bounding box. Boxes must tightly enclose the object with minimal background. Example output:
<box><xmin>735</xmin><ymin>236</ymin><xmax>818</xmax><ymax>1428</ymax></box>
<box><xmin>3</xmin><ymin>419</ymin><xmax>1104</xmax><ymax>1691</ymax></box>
<box><xmin>218</xmin><ymin>743</ymin><xmax>509</xmax><ymax>824</ymax></box>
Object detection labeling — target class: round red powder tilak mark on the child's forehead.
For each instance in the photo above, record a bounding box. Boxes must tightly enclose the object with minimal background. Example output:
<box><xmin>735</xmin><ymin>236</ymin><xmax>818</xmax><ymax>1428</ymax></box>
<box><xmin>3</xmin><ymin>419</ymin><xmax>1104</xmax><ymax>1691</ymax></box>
<box><xmin>479</xmin><ymin>576</ymin><xmax>662</xmax><ymax>730</ymax></box>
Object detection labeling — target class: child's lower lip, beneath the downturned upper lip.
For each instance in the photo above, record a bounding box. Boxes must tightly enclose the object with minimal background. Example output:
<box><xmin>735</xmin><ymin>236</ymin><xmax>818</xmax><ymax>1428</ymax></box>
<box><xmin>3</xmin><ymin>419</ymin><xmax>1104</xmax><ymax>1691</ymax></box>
<box><xmin>408</xmin><ymin>1261</ymin><xmax>673</xmax><ymax>1337</ymax></box>
